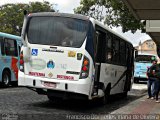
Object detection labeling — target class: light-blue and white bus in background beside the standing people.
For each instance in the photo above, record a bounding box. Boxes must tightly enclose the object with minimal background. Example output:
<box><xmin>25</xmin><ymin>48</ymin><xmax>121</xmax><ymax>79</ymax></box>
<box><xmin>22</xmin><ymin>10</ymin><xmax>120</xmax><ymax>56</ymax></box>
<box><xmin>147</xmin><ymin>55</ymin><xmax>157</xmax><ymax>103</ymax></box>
<box><xmin>134</xmin><ymin>53</ymin><xmax>158</xmax><ymax>83</ymax></box>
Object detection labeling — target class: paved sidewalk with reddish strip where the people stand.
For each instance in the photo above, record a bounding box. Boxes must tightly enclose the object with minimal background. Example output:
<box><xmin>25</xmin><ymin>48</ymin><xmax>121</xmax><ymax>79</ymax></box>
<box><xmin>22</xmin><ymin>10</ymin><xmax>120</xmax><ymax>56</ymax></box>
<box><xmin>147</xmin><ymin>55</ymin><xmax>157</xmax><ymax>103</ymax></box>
<box><xmin>100</xmin><ymin>84</ymin><xmax>160</xmax><ymax>120</ymax></box>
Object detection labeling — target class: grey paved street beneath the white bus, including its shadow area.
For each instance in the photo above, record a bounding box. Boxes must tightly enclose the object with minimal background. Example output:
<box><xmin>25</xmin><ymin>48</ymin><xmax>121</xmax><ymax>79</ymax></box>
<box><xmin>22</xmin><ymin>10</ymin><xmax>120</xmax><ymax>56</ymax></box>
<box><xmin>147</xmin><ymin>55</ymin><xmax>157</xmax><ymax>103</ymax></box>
<box><xmin>0</xmin><ymin>84</ymin><xmax>149</xmax><ymax>120</ymax></box>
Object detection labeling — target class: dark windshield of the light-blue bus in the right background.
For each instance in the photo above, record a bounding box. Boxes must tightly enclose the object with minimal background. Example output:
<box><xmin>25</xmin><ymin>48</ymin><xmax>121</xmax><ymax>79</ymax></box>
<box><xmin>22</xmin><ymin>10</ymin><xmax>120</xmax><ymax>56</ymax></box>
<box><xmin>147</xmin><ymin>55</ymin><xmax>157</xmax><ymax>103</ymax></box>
<box><xmin>135</xmin><ymin>55</ymin><xmax>155</xmax><ymax>63</ymax></box>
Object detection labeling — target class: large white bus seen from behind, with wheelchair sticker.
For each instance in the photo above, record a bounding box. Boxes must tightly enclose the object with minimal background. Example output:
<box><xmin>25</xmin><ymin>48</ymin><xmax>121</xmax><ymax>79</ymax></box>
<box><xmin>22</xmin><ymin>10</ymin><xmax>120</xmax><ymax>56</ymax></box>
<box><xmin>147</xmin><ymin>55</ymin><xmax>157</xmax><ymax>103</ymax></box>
<box><xmin>18</xmin><ymin>12</ymin><xmax>134</xmax><ymax>103</ymax></box>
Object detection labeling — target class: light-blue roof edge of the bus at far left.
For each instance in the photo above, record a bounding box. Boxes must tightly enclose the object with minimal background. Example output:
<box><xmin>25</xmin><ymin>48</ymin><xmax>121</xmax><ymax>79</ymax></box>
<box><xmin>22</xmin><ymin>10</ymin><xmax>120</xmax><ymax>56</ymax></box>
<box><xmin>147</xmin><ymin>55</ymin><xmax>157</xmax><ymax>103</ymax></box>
<box><xmin>0</xmin><ymin>32</ymin><xmax>22</xmax><ymax>44</ymax></box>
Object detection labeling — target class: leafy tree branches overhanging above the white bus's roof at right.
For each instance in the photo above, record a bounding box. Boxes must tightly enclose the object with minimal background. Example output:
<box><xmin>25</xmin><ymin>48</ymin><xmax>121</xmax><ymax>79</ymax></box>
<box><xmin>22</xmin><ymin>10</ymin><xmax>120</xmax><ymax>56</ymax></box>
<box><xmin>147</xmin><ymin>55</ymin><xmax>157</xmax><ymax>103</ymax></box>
<box><xmin>74</xmin><ymin>0</ymin><xmax>144</xmax><ymax>33</ymax></box>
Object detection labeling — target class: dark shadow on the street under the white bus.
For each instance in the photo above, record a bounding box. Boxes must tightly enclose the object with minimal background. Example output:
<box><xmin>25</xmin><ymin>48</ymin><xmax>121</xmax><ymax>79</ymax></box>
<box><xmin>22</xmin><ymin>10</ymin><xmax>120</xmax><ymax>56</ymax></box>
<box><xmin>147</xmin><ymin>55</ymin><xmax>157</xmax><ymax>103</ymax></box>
<box><xmin>32</xmin><ymin>90</ymin><xmax>145</xmax><ymax>114</ymax></box>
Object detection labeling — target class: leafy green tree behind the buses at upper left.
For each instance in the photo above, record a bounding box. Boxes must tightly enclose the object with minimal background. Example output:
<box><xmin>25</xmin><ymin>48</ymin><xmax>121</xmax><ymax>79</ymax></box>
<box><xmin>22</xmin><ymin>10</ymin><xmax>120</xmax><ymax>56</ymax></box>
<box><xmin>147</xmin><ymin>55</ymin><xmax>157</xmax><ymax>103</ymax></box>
<box><xmin>0</xmin><ymin>1</ymin><xmax>54</xmax><ymax>35</ymax></box>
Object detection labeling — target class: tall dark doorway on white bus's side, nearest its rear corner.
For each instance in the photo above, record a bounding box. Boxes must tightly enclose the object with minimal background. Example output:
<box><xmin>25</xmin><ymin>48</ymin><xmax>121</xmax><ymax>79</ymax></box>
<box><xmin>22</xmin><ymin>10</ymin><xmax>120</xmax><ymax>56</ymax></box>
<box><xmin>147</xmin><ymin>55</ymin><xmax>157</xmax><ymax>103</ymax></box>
<box><xmin>94</xmin><ymin>31</ymin><xmax>106</xmax><ymax>95</ymax></box>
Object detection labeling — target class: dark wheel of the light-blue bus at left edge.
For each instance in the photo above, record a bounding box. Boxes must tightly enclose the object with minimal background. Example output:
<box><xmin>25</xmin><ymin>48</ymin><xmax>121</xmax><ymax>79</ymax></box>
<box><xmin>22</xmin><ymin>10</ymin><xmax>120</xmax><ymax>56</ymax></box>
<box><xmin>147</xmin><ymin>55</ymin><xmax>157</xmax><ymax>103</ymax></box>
<box><xmin>2</xmin><ymin>71</ymin><xmax>10</xmax><ymax>87</ymax></box>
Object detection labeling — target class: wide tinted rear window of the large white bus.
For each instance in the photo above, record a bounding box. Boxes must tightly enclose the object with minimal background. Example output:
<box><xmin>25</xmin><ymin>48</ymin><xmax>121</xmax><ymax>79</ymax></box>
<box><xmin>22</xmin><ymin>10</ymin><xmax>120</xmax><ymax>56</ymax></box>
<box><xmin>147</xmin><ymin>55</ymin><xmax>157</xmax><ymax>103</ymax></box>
<box><xmin>27</xmin><ymin>16</ymin><xmax>89</xmax><ymax>48</ymax></box>
